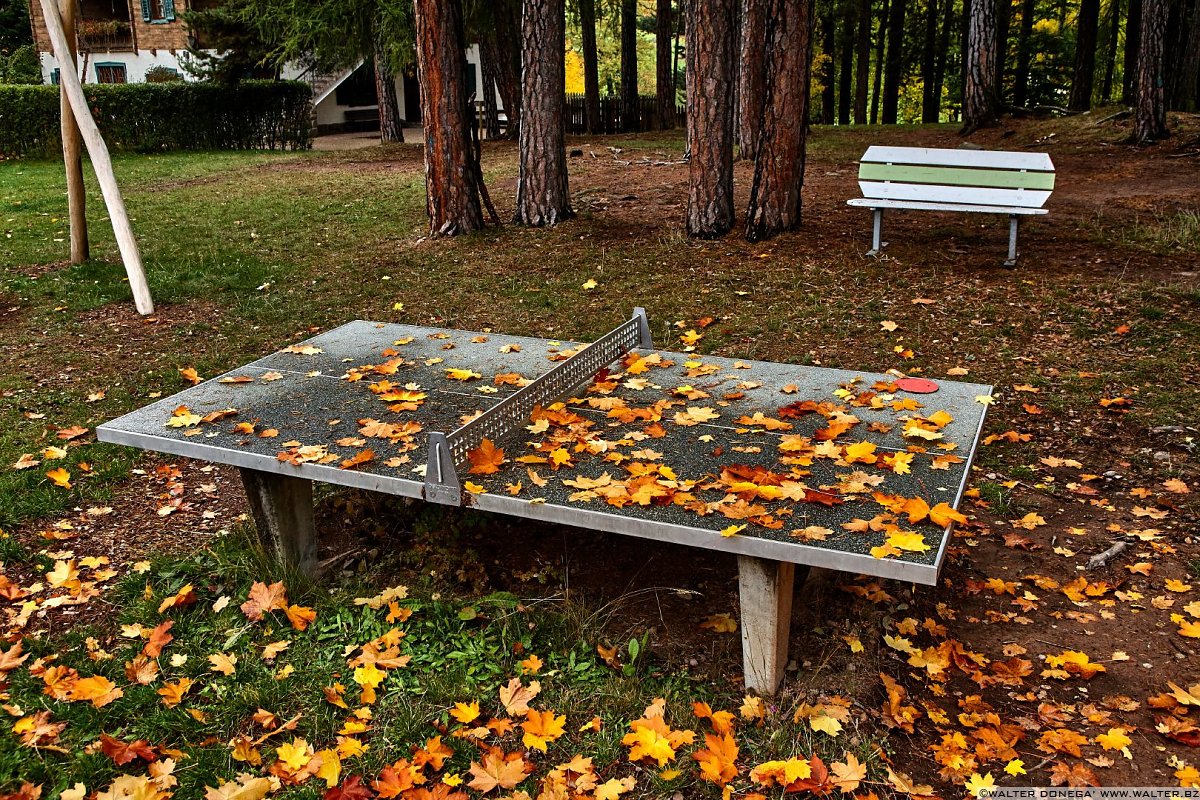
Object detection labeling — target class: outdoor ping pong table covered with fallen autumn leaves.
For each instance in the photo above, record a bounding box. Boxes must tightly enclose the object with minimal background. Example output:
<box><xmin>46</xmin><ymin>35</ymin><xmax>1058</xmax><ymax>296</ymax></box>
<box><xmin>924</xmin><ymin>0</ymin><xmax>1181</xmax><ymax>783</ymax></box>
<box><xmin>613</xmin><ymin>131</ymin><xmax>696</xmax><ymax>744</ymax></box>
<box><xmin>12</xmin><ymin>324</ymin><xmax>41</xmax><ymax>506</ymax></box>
<box><xmin>97</xmin><ymin>308</ymin><xmax>991</xmax><ymax>692</ymax></box>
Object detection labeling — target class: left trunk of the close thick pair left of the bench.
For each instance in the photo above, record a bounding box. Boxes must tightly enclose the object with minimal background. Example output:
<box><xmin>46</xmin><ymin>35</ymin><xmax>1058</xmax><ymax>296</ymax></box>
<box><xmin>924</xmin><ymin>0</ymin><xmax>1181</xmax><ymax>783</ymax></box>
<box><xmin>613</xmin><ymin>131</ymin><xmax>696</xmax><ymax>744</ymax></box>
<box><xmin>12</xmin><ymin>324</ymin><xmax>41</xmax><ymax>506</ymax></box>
<box><xmin>686</xmin><ymin>0</ymin><xmax>739</xmax><ymax>239</ymax></box>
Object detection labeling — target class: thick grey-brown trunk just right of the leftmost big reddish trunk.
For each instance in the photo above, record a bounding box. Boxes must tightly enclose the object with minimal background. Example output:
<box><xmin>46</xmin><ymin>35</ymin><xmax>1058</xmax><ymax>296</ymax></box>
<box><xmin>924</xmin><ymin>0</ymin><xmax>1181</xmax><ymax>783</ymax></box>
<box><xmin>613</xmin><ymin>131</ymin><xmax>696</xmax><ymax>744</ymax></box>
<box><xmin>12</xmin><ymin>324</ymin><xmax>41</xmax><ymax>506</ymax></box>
<box><xmin>514</xmin><ymin>0</ymin><xmax>574</xmax><ymax>227</ymax></box>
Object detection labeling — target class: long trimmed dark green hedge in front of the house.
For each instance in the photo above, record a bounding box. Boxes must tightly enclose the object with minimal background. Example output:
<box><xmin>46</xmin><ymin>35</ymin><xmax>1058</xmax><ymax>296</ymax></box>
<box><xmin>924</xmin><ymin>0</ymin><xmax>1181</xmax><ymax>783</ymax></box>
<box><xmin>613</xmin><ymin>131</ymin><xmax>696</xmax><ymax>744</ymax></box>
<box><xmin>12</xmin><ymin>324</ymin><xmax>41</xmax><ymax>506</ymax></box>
<box><xmin>0</xmin><ymin>80</ymin><xmax>312</xmax><ymax>158</ymax></box>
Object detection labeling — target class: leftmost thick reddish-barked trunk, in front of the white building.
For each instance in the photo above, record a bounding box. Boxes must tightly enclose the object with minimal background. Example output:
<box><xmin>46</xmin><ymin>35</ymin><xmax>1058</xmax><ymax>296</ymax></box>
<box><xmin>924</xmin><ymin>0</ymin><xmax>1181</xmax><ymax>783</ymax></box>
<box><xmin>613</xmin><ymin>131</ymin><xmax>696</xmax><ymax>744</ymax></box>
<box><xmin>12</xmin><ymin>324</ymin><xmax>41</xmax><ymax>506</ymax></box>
<box><xmin>413</xmin><ymin>0</ymin><xmax>484</xmax><ymax>236</ymax></box>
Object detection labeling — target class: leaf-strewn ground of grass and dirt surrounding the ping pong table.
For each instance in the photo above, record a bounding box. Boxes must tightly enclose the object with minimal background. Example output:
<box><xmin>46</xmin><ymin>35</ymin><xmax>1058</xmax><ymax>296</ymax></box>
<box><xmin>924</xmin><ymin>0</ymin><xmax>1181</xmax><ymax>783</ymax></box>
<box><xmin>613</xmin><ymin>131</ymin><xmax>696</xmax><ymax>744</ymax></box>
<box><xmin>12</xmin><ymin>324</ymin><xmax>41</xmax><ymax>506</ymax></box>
<box><xmin>0</xmin><ymin>113</ymin><xmax>1200</xmax><ymax>798</ymax></box>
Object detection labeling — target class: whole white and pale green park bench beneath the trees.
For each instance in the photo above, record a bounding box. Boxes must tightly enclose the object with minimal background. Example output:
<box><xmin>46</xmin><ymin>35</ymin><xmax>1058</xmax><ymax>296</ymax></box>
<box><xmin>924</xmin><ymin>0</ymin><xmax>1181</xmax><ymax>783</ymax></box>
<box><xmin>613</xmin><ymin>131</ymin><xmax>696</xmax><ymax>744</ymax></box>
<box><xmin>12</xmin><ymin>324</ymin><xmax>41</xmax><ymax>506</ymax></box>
<box><xmin>847</xmin><ymin>145</ymin><xmax>1055</xmax><ymax>267</ymax></box>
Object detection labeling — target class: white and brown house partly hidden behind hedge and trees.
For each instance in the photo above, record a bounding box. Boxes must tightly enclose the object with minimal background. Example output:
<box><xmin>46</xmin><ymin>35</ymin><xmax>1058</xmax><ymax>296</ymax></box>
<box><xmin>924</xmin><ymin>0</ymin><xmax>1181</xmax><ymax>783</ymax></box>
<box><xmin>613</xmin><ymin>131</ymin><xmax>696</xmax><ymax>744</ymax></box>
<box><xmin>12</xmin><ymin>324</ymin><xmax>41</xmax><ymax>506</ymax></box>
<box><xmin>29</xmin><ymin>0</ymin><xmax>503</xmax><ymax>133</ymax></box>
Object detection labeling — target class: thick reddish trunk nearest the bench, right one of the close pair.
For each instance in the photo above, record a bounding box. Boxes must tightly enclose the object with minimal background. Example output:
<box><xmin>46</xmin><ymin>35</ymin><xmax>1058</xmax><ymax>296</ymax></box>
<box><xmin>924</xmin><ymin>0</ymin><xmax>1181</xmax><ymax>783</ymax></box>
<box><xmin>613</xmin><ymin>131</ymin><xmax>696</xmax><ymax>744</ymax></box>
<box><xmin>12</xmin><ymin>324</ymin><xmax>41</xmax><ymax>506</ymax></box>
<box><xmin>746</xmin><ymin>0</ymin><xmax>812</xmax><ymax>241</ymax></box>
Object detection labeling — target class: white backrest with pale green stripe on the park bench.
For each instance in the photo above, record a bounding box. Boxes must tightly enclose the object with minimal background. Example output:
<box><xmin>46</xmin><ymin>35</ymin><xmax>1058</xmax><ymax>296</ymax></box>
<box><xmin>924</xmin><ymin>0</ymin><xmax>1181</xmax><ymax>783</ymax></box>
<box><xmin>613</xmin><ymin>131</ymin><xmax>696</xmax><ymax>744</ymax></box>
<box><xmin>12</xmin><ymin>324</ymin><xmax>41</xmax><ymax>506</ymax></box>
<box><xmin>858</xmin><ymin>145</ymin><xmax>1054</xmax><ymax>209</ymax></box>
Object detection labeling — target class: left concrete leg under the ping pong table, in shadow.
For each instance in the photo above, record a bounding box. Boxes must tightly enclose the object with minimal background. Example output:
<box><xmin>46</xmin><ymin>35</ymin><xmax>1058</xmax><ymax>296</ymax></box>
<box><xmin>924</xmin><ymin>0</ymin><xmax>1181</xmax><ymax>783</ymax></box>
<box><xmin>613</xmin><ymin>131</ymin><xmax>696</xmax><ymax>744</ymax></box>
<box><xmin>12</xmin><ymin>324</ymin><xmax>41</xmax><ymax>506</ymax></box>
<box><xmin>239</xmin><ymin>469</ymin><xmax>317</xmax><ymax>575</ymax></box>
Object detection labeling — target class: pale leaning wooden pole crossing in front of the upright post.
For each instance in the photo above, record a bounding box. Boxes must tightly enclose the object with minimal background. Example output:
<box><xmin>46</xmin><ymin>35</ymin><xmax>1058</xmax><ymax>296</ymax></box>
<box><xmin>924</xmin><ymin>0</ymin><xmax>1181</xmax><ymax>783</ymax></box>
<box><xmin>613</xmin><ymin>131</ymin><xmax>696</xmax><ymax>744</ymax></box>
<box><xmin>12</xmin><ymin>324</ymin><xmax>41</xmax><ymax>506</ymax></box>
<box><xmin>41</xmin><ymin>0</ymin><xmax>154</xmax><ymax>314</ymax></box>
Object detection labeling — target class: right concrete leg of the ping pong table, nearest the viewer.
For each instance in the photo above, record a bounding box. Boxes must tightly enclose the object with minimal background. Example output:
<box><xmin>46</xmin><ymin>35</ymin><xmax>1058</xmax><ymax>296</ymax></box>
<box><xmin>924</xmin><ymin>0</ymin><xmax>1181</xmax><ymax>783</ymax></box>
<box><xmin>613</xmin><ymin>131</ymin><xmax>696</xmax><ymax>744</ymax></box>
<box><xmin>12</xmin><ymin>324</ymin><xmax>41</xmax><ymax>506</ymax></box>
<box><xmin>738</xmin><ymin>555</ymin><xmax>808</xmax><ymax>694</ymax></box>
